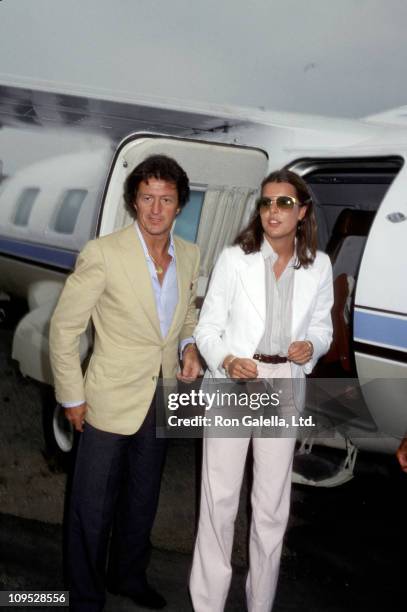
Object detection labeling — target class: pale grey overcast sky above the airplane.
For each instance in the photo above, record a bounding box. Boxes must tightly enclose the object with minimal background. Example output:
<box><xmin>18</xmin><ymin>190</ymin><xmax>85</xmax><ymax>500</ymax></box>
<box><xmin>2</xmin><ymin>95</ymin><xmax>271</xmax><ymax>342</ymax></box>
<box><xmin>0</xmin><ymin>0</ymin><xmax>407</xmax><ymax>118</ymax></box>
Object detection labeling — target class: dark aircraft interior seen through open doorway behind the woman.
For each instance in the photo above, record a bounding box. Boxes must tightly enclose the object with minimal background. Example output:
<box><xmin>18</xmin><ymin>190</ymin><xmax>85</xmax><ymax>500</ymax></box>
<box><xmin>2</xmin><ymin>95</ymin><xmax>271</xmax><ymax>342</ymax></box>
<box><xmin>291</xmin><ymin>156</ymin><xmax>403</xmax><ymax>377</ymax></box>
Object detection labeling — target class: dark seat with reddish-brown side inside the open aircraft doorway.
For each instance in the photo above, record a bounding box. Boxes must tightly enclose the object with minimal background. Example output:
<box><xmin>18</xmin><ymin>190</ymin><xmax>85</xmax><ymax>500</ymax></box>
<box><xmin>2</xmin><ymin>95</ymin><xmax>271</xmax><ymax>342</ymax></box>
<box><xmin>322</xmin><ymin>208</ymin><xmax>376</xmax><ymax>373</ymax></box>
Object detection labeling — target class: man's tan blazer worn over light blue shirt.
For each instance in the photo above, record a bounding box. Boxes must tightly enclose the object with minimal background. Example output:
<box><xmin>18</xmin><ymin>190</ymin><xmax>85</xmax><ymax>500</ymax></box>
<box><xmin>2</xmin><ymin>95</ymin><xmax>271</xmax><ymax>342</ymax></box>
<box><xmin>50</xmin><ymin>225</ymin><xmax>199</xmax><ymax>434</ymax></box>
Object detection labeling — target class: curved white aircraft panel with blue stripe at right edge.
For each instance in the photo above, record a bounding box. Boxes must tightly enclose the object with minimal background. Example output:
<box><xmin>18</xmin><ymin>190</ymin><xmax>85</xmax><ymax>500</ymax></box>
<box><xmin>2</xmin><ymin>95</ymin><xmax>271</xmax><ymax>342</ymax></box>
<box><xmin>353</xmin><ymin>166</ymin><xmax>407</xmax><ymax>453</ymax></box>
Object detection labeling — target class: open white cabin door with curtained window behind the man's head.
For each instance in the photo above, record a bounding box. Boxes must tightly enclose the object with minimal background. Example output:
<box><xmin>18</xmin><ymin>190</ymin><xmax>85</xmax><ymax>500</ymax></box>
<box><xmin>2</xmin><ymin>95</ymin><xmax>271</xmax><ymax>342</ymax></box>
<box><xmin>98</xmin><ymin>134</ymin><xmax>268</xmax><ymax>296</ymax></box>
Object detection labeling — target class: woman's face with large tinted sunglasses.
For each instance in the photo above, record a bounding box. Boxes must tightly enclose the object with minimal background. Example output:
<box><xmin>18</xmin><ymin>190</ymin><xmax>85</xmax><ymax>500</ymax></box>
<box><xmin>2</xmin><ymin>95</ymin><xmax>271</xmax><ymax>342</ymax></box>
<box><xmin>260</xmin><ymin>183</ymin><xmax>307</xmax><ymax>244</ymax></box>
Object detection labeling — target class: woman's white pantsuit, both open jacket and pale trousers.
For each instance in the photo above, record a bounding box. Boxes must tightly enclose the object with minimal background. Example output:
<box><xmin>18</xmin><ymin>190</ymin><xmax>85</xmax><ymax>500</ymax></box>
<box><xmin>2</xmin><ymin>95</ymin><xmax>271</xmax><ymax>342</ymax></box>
<box><xmin>190</xmin><ymin>246</ymin><xmax>333</xmax><ymax>612</ymax></box>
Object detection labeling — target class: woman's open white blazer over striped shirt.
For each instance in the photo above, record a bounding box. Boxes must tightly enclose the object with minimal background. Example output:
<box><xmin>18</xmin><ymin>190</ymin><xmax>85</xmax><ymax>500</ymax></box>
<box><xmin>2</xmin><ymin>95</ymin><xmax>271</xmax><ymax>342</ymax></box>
<box><xmin>194</xmin><ymin>246</ymin><xmax>333</xmax><ymax>378</ymax></box>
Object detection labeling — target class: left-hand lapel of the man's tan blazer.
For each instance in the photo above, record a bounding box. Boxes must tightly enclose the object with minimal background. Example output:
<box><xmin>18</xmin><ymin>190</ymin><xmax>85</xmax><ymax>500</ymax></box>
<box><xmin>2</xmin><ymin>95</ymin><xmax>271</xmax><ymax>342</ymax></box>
<box><xmin>118</xmin><ymin>225</ymin><xmax>162</xmax><ymax>340</ymax></box>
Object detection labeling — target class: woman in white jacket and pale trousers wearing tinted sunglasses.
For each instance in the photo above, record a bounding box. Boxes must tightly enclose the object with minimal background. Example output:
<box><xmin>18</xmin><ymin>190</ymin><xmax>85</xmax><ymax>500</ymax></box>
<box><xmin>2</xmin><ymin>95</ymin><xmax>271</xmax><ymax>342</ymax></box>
<box><xmin>190</xmin><ymin>170</ymin><xmax>333</xmax><ymax>612</ymax></box>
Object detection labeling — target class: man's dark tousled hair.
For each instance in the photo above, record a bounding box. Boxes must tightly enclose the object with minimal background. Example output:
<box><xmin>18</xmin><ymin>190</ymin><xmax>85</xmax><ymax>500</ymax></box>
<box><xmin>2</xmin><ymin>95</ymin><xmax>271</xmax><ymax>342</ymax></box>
<box><xmin>124</xmin><ymin>155</ymin><xmax>189</xmax><ymax>217</ymax></box>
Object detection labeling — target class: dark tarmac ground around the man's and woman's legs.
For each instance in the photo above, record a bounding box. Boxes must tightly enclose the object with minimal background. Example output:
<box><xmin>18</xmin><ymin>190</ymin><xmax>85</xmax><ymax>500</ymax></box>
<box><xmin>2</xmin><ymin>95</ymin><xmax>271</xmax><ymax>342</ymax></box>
<box><xmin>0</xmin><ymin>330</ymin><xmax>407</xmax><ymax>612</ymax></box>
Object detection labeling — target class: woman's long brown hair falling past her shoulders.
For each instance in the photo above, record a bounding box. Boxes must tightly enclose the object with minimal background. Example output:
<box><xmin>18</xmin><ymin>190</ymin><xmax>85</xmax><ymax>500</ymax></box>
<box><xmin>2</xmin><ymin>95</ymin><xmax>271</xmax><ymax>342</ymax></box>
<box><xmin>234</xmin><ymin>168</ymin><xmax>317</xmax><ymax>269</ymax></box>
